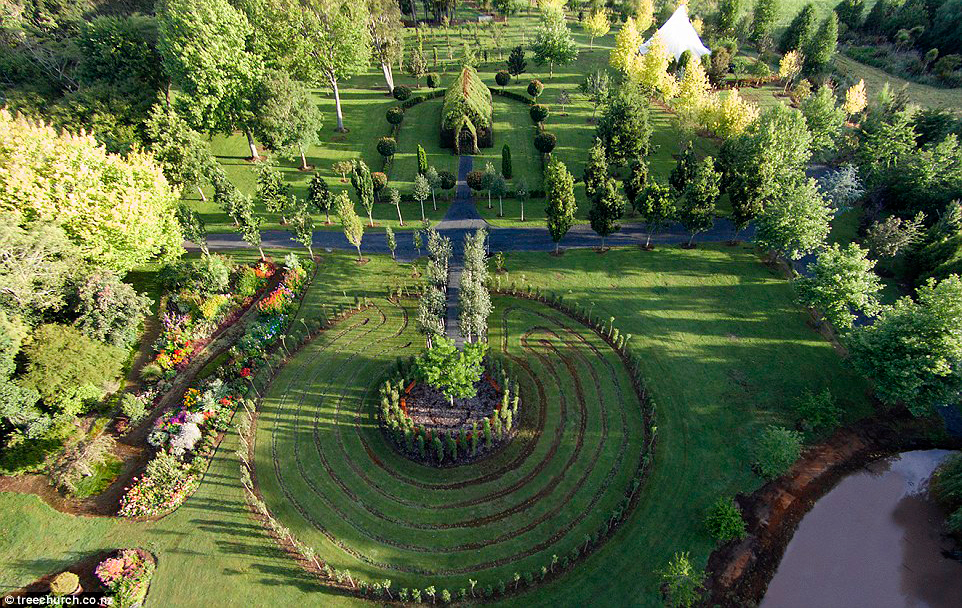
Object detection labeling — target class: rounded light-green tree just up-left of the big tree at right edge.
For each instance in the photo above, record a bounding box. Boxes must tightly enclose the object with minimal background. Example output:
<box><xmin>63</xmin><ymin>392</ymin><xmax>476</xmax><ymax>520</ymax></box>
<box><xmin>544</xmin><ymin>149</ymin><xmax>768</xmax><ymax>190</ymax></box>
<box><xmin>795</xmin><ymin>243</ymin><xmax>882</xmax><ymax>330</ymax></box>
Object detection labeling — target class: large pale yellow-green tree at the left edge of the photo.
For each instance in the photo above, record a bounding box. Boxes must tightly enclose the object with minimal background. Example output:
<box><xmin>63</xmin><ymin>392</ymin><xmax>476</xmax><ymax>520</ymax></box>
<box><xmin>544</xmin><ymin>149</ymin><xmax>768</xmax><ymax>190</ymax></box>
<box><xmin>0</xmin><ymin>109</ymin><xmax>184</xmax><ymax>275</ymax></box>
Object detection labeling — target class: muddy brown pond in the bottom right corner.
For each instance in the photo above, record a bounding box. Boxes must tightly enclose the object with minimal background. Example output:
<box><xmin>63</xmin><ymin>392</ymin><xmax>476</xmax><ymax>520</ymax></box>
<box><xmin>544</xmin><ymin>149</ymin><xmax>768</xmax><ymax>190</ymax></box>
<box><xmin>761</xmin><ymin>450</ymin><xmax>962</xmax><ymax>608</ymax></box>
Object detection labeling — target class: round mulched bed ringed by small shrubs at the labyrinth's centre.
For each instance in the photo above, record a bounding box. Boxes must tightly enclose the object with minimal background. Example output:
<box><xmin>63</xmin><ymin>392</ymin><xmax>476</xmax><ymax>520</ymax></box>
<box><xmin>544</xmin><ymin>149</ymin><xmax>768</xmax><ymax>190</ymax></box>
<box><xmin>379</xmin><ymin>361</ymin><xmax>521</xmax><ymax>466</ymax></box>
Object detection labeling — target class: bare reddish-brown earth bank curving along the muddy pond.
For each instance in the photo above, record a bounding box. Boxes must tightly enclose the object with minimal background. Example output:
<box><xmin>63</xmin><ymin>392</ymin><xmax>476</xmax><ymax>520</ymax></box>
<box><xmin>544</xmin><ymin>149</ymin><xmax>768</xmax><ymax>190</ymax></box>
<box><xmin>705</xmin><ymin>409</ymin><xmax>962</xmax><ymax>606</ymax></box>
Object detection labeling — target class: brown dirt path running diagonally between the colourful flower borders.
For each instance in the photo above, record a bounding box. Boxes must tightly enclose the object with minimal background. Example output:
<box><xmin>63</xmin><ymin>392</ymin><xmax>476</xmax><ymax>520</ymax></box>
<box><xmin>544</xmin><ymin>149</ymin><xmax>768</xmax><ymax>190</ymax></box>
<box><xmin>0</xmin><ymin>268</ymin><xmax>284</xmax><ymax>520</ymax></box>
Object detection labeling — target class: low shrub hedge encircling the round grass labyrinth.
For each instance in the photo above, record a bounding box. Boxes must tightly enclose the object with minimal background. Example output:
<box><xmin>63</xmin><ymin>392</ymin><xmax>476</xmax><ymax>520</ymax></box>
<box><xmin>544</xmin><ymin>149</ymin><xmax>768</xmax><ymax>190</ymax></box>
<box><xmin>241</xmin><ymin>289</ymin><xmax>657</xmax><ymax>603</ymax></box>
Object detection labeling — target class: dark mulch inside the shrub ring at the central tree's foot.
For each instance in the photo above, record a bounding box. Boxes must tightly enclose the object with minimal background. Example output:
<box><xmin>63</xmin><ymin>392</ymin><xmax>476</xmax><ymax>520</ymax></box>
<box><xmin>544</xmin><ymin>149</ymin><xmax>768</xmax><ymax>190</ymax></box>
<box><xmin>404</xmin><ymin>374</ymin><xmax>501</xmax><ymax>432</ymax></box>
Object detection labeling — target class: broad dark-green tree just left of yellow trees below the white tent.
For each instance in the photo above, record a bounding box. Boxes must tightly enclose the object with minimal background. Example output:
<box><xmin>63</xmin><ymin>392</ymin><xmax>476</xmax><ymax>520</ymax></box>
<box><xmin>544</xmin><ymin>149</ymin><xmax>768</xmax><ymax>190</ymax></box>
<box><xmin>595</xmin><ymin>86</ymin><xmax>651</xmax><ymax>164</ymax></box>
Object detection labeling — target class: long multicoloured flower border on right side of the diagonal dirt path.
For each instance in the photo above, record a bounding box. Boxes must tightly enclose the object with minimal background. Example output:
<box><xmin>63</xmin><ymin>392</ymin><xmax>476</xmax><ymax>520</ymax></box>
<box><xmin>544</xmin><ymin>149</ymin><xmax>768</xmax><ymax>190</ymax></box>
<box><xmin>119</xmin><ymin>255</ymin><xmax>313</xmax><ymax>517</ymax></box>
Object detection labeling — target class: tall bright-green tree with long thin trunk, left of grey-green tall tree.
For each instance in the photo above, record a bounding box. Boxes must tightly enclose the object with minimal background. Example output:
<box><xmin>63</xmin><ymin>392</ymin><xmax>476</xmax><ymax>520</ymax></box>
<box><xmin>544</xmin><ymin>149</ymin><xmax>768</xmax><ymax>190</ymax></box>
<box><xmin>293</xmin><ymin>0</ymin><xmax>371</xmax><ymax>133</ymax></box>
